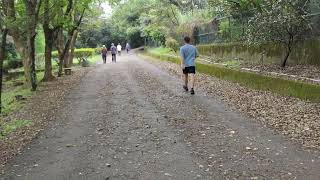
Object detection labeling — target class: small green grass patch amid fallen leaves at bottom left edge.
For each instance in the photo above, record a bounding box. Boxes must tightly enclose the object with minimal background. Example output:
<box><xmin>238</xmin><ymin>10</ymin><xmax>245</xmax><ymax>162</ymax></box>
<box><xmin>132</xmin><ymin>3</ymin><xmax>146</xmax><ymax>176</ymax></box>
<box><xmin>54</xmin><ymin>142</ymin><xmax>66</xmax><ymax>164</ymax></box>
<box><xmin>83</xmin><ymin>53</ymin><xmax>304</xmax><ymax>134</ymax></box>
<box><xmin>0</xmin><ymin>120</ymin><xmax>32</xmax><ymax>139</ymax></box>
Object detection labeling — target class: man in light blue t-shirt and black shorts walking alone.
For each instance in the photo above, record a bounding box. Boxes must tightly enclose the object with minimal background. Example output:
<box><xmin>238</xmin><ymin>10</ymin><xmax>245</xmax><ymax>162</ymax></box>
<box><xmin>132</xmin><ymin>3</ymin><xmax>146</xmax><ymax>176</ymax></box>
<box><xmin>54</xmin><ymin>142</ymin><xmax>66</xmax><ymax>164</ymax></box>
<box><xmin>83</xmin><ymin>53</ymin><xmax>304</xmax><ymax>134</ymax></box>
<box><xmin>180</xmin><ymin>36</ymin><xmax>199</xmax><ymax>95</ymax></box>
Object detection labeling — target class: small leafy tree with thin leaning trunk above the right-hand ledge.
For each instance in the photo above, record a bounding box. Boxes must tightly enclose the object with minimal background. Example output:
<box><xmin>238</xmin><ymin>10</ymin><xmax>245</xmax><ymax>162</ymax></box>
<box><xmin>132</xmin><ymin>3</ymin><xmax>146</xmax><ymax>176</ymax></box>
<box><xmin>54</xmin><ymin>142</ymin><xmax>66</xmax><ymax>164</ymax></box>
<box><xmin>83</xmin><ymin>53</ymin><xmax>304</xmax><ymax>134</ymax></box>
<box><xmin>248</xmin><ymin>0</ymin><xmax>310</xmax><ymax>67</ymax></box>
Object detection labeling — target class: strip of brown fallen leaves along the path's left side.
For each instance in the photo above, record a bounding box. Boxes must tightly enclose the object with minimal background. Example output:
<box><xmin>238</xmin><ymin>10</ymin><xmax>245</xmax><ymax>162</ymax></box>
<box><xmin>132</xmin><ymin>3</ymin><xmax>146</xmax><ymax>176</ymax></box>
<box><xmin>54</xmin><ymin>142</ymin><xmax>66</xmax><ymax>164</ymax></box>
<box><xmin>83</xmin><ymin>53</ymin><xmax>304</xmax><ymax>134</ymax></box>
<box><xmin>0</xmin><ymin>68</ymin><xmax>91</xmax><ymax>174</ymax></box>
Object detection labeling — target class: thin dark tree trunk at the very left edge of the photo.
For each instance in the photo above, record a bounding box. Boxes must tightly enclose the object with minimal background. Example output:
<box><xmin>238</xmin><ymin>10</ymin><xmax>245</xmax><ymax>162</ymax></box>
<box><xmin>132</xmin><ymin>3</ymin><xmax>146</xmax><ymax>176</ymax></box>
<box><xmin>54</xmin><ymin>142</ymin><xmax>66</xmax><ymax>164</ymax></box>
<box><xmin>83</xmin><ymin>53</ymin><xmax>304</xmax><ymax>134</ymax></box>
<box><xmin>0</xmin><ymin>29</ymin><xmax>8</xmax><ymax>114</ymax></box>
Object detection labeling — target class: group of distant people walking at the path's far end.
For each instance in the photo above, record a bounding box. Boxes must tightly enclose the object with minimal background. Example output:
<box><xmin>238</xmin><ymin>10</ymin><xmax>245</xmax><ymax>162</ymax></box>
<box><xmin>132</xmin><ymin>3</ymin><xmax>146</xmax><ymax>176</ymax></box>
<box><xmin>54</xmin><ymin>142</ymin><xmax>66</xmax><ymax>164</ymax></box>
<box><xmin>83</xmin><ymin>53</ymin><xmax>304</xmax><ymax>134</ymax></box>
<box><xmin>101</xmin><ymin>43</ymin><xmax>131</xmax><ymax>64</ymax></box>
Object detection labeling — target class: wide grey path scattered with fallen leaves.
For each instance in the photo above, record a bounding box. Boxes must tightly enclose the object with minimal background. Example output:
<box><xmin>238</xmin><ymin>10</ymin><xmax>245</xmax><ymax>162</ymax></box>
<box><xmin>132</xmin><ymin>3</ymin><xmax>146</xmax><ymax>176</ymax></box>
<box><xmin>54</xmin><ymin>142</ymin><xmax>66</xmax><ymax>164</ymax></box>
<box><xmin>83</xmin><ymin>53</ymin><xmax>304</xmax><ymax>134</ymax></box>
<box><xmin>0</xmin><ymin>55</ymin><xmax>320</xmax><ymax>180</ymax></box>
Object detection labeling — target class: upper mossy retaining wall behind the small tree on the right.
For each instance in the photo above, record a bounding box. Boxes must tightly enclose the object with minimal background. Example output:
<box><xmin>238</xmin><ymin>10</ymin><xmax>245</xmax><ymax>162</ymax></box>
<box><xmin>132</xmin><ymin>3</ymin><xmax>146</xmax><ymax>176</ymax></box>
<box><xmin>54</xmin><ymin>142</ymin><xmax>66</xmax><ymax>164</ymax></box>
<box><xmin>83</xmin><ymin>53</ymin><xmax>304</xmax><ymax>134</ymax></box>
<box><xmin>198</xmin><ymin>39</ymin><xmax>320</xmax><ymax>65</ymax></box>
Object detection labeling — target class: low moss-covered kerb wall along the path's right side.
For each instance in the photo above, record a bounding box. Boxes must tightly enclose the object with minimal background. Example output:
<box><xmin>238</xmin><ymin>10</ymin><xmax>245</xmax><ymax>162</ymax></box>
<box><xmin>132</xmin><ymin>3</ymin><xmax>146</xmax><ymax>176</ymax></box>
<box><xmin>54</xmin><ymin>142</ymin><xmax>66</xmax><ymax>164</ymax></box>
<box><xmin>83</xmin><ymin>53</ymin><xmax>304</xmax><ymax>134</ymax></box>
<box><xmin>145</xmin><ymin>51</ymin><xmax>320</xmax><ymax>102</ymax></box>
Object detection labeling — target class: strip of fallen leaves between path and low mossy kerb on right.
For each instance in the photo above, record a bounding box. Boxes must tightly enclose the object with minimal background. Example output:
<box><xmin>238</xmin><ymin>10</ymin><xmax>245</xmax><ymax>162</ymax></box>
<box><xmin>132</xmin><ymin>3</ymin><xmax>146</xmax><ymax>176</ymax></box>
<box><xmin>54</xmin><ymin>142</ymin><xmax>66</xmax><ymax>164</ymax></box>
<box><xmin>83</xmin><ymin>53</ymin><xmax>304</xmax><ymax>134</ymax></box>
<box><xmin>149</xmin><ymin>58</ymin><xmax>320</xmax><ymax>149</ymax></box>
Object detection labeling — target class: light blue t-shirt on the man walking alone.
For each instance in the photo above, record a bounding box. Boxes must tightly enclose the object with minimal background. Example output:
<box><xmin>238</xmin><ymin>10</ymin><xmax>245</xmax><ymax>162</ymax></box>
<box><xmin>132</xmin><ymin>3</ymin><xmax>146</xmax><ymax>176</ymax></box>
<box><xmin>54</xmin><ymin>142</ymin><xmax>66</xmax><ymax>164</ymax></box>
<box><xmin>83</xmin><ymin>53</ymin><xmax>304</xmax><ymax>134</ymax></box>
<box><xmin>180</xmin><ymin>44</ymin><xmax>198</xmax><ymax>67</ymax></box>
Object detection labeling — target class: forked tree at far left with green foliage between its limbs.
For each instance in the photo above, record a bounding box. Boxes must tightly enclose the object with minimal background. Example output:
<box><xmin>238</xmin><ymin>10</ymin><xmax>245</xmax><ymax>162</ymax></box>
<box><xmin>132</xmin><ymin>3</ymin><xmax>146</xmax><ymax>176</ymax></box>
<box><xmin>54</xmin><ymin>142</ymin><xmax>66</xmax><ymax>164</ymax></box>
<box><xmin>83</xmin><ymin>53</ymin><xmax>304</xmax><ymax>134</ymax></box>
<box><xmin>1</xmin><ymin>0</ymin><xmax>42</xmax><ymax>91</ymax></box>
